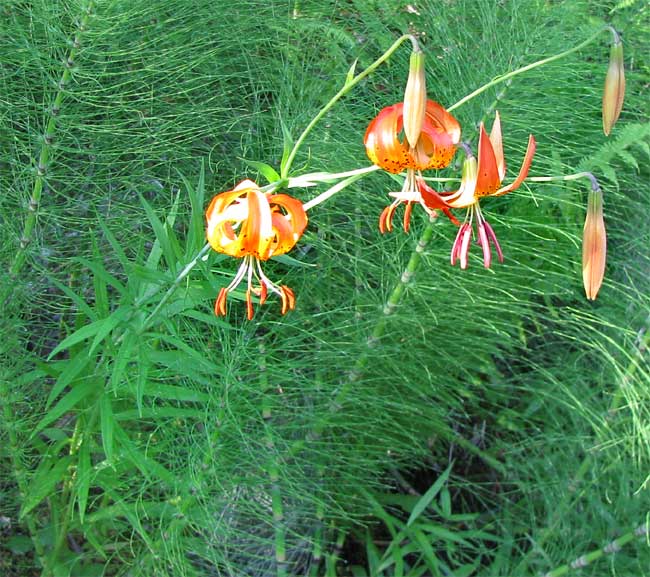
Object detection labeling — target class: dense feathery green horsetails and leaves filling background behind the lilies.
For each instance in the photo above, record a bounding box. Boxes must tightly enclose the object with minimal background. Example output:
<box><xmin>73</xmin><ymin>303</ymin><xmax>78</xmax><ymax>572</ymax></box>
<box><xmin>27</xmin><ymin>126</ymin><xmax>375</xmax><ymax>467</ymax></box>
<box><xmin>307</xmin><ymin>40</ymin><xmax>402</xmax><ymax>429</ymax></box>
<box><xmin>0</xmin><ymin>0</ymin><xmax>650</xmax><ymax>577</ymax></box>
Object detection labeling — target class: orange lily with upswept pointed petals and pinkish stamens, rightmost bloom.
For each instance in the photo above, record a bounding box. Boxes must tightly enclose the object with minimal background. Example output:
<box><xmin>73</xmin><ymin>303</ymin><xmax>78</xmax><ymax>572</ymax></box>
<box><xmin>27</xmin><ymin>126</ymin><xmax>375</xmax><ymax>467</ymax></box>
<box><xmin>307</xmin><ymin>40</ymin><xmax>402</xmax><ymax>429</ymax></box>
<box><xmin>431</xmin><ymin>112</ymin><xmax>537</xmax><ymax>269</ymax></box>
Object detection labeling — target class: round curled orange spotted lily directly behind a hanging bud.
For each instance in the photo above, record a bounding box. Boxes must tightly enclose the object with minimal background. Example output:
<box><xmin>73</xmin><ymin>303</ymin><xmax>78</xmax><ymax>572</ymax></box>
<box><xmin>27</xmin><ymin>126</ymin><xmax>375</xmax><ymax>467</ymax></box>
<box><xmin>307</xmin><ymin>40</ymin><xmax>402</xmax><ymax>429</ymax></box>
<box><xmin>364</xmin><ymin>99</ymin><xmax>460</xmax><ymax>233</ymax></box>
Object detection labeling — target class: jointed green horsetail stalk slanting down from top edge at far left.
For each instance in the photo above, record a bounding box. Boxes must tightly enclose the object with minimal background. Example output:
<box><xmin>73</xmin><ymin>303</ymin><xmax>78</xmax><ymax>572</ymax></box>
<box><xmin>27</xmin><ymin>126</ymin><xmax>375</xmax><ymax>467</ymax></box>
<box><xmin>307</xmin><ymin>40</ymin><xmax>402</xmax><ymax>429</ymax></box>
<box><xmin>10</xmin><ymin>0</ymin><xmax>93</xmax><ymax>275</ymax></box>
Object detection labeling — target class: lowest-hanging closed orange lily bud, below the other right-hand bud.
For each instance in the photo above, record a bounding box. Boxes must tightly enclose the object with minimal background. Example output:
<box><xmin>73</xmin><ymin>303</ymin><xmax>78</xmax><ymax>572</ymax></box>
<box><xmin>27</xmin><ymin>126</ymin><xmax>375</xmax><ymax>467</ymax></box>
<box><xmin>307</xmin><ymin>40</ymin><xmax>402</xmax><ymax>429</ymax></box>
<box><xmin>582</xmin><ymin>187</ymin><xmax>607</xmax><ymax>301</ymax></box>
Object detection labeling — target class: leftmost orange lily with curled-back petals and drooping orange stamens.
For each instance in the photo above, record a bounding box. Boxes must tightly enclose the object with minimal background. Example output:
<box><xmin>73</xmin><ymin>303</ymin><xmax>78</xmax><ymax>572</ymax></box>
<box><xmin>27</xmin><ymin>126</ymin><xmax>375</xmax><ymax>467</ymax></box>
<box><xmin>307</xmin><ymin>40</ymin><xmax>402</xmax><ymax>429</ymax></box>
<box><xmin>205</xmin><ymin>180</ymin><xmax>307</xmax><ymax>320</ymax></box>
